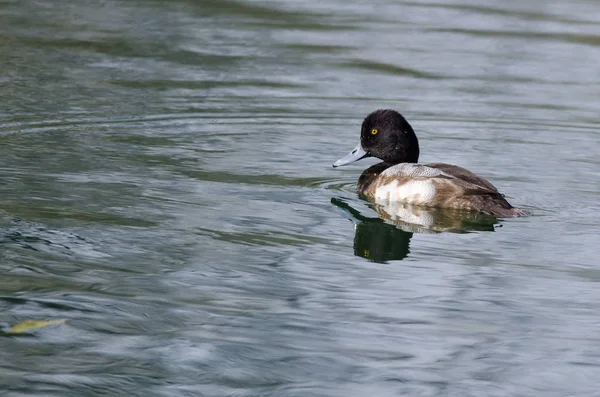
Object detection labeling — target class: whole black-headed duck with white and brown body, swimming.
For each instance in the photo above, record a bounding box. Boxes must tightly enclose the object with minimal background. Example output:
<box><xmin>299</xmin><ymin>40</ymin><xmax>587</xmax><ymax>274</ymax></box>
<box><xmin>333</xmin><ymin>109</ymin><xmax>529</xmax><ymax>217</ymax></box>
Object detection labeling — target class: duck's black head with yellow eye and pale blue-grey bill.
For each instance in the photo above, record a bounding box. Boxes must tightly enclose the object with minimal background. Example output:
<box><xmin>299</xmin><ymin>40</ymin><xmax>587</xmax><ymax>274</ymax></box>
<box><xmin>333</xmin><ymin>109</ymin><xmax>419</xmax><ymax>167</ymax></box>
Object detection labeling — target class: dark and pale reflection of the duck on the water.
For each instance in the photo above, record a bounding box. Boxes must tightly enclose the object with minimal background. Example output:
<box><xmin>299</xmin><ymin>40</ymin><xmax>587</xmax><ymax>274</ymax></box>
<box><xmin>331</xmin><ymin>197</ymin><xmax>498</xmax><ymax>262</ymax></box>
